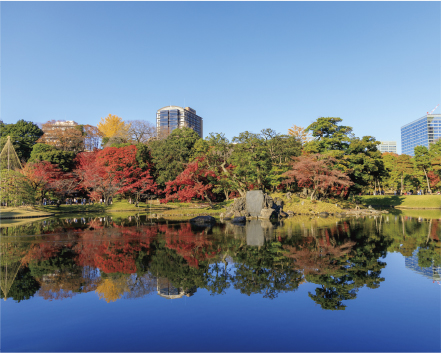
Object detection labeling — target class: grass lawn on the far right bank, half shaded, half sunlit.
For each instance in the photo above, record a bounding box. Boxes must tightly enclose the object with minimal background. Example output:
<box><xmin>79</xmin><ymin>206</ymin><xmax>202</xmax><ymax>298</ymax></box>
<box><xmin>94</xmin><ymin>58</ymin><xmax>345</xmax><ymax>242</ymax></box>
<box><xmin>360</xmin><ymin>195</ymin><xmax>441</xmax><ymax>209</ymax></box>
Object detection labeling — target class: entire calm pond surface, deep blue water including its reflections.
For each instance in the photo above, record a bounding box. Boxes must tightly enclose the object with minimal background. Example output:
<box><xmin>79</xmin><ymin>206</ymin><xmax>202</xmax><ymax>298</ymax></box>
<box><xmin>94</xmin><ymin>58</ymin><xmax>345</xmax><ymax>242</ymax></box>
<box><xmin>1</xmin><ymin>210</ymin><xmax>441</xmax><ymax>352</ymax></box>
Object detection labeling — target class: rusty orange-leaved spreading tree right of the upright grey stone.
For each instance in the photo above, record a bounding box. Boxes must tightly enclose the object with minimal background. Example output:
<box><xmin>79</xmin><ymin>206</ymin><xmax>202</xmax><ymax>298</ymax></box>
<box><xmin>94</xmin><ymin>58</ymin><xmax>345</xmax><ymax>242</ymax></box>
<box><xmin>283</xmin><ymin>154</ymin><xmax>353</xmax><ymax>200</ymax></box>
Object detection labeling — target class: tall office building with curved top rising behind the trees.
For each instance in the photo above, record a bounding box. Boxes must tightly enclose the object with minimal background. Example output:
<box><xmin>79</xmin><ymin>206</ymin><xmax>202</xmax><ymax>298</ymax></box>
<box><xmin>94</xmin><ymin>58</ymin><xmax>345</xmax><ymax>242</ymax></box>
<box><xmin>156</xmin><ymin>105</ymin><xmax>203</xmax><ymax>138</ymax></box>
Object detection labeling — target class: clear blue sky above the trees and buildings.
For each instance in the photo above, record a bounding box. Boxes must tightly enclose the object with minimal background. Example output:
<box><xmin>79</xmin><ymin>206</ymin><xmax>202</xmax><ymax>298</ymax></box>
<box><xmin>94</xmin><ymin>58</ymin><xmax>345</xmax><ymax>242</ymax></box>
<box><xmin>1</xmin><ymin>2</ymin><xmax>441</xmax><ymax>150</ymax></box>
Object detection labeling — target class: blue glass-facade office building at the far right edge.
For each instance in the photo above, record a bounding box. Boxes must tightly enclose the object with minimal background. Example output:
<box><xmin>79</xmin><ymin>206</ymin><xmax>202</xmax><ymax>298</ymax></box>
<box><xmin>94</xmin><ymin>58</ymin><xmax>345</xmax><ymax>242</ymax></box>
<box><xmin>401</xmin><ymin>114</ymin><xmax>441</xmax><ymax>156</ymax></box>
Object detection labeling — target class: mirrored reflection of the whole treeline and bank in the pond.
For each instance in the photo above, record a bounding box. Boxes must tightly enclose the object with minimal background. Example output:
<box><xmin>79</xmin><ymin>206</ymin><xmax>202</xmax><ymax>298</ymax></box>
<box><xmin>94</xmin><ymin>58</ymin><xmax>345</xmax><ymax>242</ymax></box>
<box><xmin>0</xmin><ymin>215</ymin><xmax>441</xmax><ymax>310</ymax></box>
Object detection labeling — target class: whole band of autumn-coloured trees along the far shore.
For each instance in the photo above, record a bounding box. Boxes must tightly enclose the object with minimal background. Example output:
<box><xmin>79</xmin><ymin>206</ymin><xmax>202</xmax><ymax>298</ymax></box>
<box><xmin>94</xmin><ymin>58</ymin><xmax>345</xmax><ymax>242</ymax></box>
<box><xmin>1</xmin><ymin>115</ymin><xmax>441</xmax><ymax>203</ymax></box>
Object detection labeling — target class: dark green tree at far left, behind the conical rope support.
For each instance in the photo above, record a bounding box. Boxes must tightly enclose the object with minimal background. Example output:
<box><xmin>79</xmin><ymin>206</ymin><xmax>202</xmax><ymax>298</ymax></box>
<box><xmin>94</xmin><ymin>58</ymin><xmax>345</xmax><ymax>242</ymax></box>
<box><xmin>0</xmin><ymin>119</ymin><xmax>43</xmax><ymax>161</ymax></box>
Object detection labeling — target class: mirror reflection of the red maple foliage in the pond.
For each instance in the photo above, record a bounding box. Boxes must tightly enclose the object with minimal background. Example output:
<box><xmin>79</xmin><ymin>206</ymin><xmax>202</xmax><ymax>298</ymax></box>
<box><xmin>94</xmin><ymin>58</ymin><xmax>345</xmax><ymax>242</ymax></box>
<box><xmin>24</xmin><ymin>220</ymin><xmax>221</xmax><ymax>274</ymax></box>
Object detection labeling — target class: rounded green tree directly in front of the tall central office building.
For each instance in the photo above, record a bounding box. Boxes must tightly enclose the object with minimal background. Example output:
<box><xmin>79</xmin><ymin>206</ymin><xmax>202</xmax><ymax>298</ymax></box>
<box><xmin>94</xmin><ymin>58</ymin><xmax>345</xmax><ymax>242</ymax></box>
<box><xmin>149</xmin><ymin>127</ymin><xmax>200</xmax><ymax>186</ymax></box>
